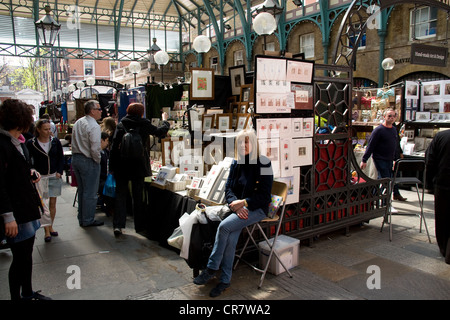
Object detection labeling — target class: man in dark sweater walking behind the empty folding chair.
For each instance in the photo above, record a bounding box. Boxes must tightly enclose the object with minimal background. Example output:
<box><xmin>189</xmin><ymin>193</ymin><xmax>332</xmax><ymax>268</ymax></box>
<box><xmin>360</xmin><ymin>108</ymin><xmax>407</xmax><ymax>201</ymax></box>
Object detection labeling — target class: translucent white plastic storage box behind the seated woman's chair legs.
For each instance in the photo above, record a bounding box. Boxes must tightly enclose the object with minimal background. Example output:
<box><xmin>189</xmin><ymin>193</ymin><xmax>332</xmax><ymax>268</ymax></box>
<box><xmin>258</xmin><ymin>234</ymin><xmax>300</xmax><ymax>275</ymax></box>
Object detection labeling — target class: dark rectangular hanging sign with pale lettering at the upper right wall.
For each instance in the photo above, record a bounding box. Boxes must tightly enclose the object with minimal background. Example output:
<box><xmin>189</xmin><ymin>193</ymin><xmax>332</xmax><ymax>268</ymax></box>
<box><xmin>411</xmin><ymin>43</ymin><xmax>448</xmax><ymax>67</ymax></box>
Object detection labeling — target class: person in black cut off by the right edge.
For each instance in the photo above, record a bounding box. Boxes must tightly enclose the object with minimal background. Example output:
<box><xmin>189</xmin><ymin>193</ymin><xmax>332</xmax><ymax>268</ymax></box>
<box><xmin>425</xmin><ymin>130</ymin><xmax>450</xmax><ymax>264</ymax></box>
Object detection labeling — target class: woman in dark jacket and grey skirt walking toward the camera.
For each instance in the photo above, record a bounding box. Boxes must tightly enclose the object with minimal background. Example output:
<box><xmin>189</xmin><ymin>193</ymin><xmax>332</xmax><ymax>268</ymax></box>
<box><xmin>27</xmin><ymin>119</ymin><xmax>65</xmax><ymax>242</ymax></box>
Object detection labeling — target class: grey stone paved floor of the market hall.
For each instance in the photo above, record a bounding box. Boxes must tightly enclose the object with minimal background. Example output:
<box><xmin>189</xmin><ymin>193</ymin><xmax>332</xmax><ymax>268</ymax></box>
<box><xmin>0</xmin><ymin>179</ymin><xmax>450</xmax><ymax>303</ymax></box>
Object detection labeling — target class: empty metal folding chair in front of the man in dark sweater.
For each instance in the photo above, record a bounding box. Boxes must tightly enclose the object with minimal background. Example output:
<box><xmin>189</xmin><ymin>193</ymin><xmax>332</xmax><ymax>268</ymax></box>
<box><xmin>380</xmin><ymin>159</ymin><xmax>431</xmax><ymax>243</ymax></box>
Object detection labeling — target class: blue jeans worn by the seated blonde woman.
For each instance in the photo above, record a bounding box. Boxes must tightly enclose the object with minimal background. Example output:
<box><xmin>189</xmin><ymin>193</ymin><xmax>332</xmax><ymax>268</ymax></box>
<box><xmin>207</xmin><ymin>209</ymin><xmax>266</xmax><ymax>283</ymax></box>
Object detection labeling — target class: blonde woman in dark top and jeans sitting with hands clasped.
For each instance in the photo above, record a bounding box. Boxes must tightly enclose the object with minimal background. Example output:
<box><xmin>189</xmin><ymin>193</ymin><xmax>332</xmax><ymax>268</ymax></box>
<box><xmin>194</xmin><ymin>129</ymin><xmax>273</xmax><ymax>297</ymax></box>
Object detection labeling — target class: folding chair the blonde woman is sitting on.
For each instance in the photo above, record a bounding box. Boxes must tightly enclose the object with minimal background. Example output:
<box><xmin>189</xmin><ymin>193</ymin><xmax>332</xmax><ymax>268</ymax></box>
<box><xmin>234</xmin><ymin>181</ymin><xmax>292</xmax><ymax>289</ymax></box>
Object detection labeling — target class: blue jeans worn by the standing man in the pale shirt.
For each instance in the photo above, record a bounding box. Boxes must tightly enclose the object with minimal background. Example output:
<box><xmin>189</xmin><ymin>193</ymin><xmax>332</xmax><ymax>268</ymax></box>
<box><xmin>72</xmin><ymin>153</ymin><xmax>100</xmax><ymax>226</ymax></box>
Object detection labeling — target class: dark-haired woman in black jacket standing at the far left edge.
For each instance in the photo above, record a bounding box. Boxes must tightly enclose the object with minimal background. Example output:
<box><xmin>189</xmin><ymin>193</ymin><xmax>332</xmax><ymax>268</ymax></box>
<box><xmin>0</xmin><ymin>99</ymin><xmax>50</xmax><ymax>300</ymax></box>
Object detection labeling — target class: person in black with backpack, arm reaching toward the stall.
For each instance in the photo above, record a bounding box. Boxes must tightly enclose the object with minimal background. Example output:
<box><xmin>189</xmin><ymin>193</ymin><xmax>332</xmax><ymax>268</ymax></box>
<box><xmin>109</xmin><ymin>103</ymin><xmax>170</xmax><ymax>236</ymax></box>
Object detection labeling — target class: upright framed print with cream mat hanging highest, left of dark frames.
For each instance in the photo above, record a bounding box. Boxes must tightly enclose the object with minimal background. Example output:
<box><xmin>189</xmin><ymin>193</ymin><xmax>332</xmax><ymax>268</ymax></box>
<box><xmin>190</xmin><ymin>68</ymin><xmax>214</xmax><ymax>100</ymax></box>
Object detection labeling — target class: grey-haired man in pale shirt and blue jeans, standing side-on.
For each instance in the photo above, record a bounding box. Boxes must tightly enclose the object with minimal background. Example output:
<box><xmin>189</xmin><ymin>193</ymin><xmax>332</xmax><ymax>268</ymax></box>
<box><xmin>72</xmin><ymin>100</ymin><xmax>104</xmax><ymax>227</ymax></box>
